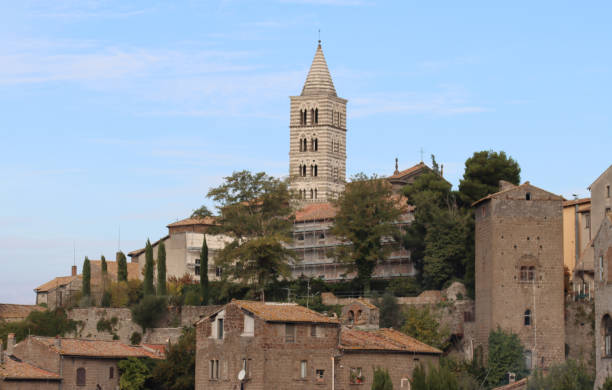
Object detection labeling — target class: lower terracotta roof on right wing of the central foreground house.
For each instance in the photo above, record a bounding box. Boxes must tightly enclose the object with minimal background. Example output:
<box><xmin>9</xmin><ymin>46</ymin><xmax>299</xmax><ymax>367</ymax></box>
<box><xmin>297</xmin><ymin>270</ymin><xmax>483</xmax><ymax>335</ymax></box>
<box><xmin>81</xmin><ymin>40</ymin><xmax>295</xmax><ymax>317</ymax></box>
<box><xmin>340</xmin><ymin>328</ymin><xmax>442</xmax><ymax>355</ymax></box>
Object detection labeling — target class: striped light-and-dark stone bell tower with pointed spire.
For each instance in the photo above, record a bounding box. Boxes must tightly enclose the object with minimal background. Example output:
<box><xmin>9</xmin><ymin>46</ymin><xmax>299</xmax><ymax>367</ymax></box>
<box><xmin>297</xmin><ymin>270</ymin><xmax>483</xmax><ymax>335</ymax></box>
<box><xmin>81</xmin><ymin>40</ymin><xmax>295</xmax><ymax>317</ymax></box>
<box><xmin>289</xmin><ymin>41</ymin><xmax>347</xmax><ymax>203</ymax></box>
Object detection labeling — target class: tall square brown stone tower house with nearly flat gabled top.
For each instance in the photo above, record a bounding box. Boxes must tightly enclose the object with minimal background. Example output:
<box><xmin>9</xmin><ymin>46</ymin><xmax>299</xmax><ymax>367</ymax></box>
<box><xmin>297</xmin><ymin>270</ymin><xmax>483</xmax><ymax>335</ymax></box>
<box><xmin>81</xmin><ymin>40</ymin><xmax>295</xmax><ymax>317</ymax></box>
<box><xmin>473</xmin><ymin>182</ymin><xmax>565</xmax><ymax>368</ymax></box>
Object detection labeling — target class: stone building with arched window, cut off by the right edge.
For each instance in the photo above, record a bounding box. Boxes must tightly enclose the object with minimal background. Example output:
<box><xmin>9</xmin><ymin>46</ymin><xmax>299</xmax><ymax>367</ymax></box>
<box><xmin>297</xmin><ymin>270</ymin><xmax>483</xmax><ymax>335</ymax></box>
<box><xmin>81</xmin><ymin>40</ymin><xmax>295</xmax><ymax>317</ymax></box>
<box><xmin>593</xmin><ymin>213</ymin><xmax>612</xmax><ymax>388</ymax></box>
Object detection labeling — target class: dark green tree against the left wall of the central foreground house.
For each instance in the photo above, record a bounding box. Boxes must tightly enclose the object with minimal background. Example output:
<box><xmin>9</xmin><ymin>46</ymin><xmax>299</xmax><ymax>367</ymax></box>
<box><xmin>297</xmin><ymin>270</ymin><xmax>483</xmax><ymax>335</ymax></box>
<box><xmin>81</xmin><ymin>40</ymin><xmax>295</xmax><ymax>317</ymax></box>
<box><xmin>152</xmin><ymin>328</ymin><xmax>196</xmax><ymax>390</ymax></box>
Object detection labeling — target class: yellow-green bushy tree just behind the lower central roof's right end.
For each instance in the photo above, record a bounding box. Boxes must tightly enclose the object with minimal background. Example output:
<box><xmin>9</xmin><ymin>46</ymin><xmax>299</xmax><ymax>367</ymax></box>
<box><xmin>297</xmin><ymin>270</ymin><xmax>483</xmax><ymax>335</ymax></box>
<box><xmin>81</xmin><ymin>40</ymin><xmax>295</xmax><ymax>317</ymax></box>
<box><xmin>402</xmin><ymin>306</ymin><xmax>450</xmax><ymax>350</ymax></box>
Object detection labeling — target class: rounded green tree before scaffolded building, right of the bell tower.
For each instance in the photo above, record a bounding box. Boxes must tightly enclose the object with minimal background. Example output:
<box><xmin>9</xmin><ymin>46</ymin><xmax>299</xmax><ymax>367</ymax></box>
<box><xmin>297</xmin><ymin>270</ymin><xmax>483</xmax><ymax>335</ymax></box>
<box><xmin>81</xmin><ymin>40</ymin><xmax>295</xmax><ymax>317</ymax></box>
<box><xmin>331</xmin><ymin>174</ymin><xmax>403</xmax><ymax>291</ymax></box>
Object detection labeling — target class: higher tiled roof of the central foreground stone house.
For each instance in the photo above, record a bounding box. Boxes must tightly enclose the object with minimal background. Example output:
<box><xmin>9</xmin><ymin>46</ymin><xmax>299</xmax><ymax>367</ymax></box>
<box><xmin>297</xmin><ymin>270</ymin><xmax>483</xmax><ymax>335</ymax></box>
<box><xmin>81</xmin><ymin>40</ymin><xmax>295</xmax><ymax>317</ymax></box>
<box><xmin>231</xmin><ymin>300</ymin><xmax>338</xmax><ymax>324</ymax></box>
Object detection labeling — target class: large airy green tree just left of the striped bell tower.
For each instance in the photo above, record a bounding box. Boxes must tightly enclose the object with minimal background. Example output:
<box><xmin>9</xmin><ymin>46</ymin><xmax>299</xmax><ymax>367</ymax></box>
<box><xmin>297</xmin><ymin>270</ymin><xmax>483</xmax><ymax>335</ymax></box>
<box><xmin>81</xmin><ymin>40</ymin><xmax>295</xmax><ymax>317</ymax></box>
<box><xmin>207</xmin><ymin>171</ymin><xmax>294</xmax><ymax>300</ymax></box>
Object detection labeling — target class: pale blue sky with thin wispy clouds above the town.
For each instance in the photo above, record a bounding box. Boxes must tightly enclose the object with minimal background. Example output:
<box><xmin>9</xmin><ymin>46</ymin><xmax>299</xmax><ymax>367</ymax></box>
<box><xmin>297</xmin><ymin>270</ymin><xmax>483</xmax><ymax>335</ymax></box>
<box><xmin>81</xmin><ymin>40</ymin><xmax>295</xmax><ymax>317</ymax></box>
<box><xmin>0</xmin><ymin>0</ymin><xmax>612</xmax><ymax>303</ymax></box>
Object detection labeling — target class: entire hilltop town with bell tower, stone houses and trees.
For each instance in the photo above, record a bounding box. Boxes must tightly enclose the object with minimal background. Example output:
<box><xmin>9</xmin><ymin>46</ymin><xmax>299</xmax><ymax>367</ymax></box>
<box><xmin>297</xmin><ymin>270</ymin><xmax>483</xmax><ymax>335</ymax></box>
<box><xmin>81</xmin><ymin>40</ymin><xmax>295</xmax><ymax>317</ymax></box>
<box><xmin>0</xmin><ymin>41</ymin><xmax>612</xmax><ymax>390</ymax></box>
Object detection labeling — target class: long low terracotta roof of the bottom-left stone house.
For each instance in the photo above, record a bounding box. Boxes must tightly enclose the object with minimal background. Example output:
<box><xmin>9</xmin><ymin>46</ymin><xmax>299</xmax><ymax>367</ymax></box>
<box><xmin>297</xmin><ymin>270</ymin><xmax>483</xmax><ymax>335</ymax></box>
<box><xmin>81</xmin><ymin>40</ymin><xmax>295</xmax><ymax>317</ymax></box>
<box><xmin>27</xmin><ymin>336</ymin><xmax>160</xmax><ymax>359</ymax></box>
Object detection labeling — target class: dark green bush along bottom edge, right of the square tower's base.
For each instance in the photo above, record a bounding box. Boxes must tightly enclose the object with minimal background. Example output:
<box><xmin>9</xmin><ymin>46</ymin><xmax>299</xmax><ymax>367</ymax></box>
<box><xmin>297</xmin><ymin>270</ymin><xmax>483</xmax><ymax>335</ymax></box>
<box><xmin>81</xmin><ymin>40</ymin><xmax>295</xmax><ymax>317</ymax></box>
<box><xmin>527</xmin><ymin>359</ymin><xmax>596</xmax><ymax>390</ymax></box>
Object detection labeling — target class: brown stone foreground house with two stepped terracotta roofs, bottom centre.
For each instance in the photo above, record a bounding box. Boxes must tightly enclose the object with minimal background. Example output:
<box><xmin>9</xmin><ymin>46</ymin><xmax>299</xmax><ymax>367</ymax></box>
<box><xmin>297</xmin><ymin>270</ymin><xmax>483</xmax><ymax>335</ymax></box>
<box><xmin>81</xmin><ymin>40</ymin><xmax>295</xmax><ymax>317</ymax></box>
<box><xmin>196</xmin><ymin>301</ymin><xmax>441</xmax><ymax>390</ymax></box>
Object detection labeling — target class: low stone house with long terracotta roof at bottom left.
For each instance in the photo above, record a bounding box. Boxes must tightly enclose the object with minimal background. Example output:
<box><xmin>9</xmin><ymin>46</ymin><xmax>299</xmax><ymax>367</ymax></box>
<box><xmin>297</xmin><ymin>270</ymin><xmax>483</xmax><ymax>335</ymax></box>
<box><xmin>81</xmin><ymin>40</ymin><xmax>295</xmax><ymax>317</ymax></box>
<box><xmin>12</xmin><ymin>336</ymin><xmax>161</xmax><ymax>390</ymax></box>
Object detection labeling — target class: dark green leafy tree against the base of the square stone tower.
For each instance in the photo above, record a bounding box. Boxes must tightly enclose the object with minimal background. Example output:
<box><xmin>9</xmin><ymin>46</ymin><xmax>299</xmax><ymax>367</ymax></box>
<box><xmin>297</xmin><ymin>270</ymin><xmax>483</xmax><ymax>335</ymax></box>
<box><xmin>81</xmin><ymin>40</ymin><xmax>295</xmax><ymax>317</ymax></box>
<box><xmin>487</xmin><ymin>328</ymin><xmax>524</xmax><ymax>387</ymax></box>
